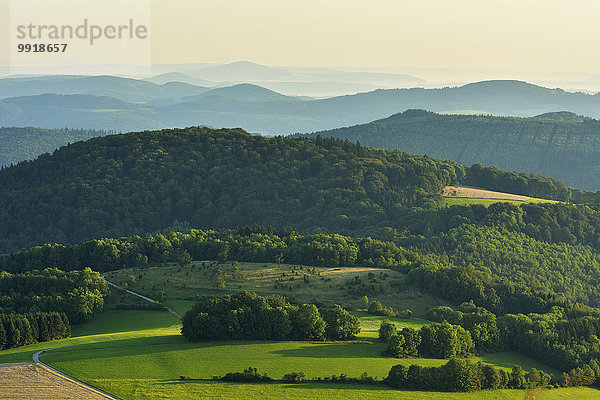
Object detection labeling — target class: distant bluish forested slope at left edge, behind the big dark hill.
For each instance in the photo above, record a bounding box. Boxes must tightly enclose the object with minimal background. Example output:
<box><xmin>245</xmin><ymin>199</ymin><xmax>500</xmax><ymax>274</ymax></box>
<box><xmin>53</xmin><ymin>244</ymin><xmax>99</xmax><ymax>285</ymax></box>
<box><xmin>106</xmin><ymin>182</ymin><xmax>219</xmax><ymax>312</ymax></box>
<box><xmin>0</xmin><ymin>128</ymin><xmax>114</xmax><ymax>166</ymax></box>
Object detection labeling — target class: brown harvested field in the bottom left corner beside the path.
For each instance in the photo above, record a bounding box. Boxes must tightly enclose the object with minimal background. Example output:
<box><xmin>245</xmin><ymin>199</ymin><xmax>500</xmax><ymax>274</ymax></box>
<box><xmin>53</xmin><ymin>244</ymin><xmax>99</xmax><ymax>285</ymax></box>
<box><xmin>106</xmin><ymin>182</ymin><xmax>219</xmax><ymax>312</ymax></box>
<box><xmin>0</xmin><ymin>363</ymin><xmax>119</xmax><ymax>400</ymax></box>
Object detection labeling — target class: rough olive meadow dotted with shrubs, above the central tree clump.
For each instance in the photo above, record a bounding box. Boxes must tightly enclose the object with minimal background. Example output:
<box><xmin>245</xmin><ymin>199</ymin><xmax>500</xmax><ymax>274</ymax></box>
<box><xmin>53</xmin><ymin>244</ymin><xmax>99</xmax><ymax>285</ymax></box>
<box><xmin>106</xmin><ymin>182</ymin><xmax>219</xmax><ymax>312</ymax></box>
<box><xmin>106</xmin><ymin>262</ymin><xmax>447</xmax><ymax>316</ymax></box>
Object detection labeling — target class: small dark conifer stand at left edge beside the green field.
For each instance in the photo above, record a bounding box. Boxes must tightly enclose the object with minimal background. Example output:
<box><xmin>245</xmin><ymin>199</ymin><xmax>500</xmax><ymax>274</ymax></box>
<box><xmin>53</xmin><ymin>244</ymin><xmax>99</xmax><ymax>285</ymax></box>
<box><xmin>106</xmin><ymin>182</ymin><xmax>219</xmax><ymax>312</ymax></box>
<box><xmin>0</xmin><ymin>312</ymin><xmax>71</xmax><ymax>350</ymax></box>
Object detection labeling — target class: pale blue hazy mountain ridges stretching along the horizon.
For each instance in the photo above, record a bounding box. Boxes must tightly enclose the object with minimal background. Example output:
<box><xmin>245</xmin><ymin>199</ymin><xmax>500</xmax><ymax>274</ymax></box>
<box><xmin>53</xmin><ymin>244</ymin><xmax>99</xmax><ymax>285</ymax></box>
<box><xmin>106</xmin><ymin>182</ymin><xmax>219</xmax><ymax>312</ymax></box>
<box><xmin>0</xmin><ymin>63</ymin><xmax>600</xmax><ymax>135</ymax></box>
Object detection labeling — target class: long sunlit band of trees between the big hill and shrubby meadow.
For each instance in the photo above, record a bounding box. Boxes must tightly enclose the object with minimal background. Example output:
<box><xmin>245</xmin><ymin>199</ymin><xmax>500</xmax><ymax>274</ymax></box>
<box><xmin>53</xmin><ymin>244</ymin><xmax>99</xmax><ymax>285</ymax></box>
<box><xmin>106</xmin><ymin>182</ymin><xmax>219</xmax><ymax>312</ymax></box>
<box><xmin>0</xmin><ymin>225</ymin><xmax>419</xmax><ymax>272</ymax></box>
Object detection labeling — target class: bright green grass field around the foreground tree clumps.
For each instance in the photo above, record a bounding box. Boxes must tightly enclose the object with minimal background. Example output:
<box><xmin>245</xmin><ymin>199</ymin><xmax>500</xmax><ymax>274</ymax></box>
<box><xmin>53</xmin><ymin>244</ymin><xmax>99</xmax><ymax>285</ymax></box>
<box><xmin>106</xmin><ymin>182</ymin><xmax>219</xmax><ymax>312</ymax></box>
<box><xmin>0</xmin><ymin>302</ymin><xmax>576</xmax><ymax>400</ymax></box>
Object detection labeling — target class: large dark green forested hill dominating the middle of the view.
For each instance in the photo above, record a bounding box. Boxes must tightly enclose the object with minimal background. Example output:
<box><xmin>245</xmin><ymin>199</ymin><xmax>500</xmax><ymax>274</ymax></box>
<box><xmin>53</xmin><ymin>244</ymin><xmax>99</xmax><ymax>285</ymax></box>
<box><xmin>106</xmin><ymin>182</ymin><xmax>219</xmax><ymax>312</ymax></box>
<box><xmin>0</xmin><ymin>128</ymin><xmax>465</xmax><ymax>252</ymax></box>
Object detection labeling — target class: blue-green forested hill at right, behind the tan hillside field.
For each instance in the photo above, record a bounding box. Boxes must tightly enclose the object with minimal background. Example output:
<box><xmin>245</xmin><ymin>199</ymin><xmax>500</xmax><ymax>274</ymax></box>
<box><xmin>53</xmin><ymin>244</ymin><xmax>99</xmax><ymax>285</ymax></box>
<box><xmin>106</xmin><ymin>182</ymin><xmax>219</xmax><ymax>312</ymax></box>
<box><xmin>309</xmin><ymin>110</ymin><xmax>600</xmax><ymax>191</ymax></box>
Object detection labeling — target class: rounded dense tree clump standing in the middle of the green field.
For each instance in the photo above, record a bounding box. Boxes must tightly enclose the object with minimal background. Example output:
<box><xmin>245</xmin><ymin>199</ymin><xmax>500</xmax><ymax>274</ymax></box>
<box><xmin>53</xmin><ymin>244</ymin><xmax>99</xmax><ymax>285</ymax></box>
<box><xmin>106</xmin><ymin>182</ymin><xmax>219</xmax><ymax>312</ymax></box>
<box><xmin>181</xmin><ymin>291</ymin><xmax>360</xmax><ymax>341</ymax></box>
